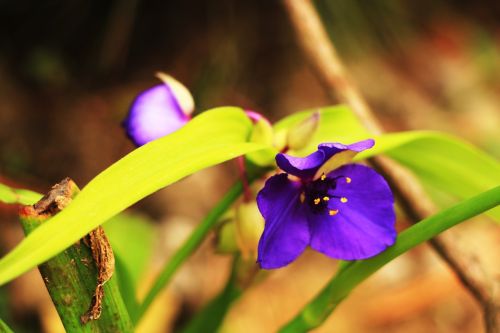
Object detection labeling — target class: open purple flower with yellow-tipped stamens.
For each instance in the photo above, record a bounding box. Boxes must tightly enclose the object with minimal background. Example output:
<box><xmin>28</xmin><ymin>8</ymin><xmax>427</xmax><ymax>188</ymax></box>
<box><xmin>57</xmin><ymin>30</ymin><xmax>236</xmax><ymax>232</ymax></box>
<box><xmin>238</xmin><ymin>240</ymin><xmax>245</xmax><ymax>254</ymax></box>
<box><xmin>257</xmin><ymin>140</ymin><xmax>396</xmax><ymax>269</ymax></box>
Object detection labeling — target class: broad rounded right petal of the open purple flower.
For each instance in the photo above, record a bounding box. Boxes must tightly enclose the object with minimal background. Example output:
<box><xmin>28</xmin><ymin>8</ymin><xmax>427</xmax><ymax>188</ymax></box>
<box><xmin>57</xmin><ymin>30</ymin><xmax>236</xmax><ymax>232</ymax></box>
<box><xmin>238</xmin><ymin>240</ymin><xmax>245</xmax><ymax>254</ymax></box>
<box><xmin>309</xmin><ymin>164</ymin><xmax>396</xmax><ymax>260</ymax></box>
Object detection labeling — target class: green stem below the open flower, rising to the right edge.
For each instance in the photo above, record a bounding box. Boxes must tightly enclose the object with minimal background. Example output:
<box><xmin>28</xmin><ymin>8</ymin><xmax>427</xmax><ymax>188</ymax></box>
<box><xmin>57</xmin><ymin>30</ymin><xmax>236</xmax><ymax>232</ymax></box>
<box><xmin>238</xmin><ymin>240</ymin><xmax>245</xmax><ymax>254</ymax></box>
<box><xmin>280</xmin><ymin>186</ymin><xmax>500</xmax><ymax>333</ymax></box>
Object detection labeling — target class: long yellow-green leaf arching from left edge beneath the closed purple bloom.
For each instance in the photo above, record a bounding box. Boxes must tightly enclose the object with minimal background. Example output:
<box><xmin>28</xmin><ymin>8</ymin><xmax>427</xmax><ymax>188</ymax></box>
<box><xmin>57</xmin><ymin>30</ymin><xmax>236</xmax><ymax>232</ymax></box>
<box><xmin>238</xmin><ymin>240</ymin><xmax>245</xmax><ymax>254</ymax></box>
<box><xmin>0</xmin><ymin>107</ymin><xmax>262</xmax><ymax>285</ymax></box>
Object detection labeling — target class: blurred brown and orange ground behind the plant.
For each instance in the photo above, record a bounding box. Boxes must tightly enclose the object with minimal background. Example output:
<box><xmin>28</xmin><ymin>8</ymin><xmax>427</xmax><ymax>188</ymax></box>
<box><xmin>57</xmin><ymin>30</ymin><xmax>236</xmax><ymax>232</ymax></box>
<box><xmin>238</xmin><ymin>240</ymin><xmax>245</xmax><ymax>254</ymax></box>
<box><xmin>0</xmin><ymin>0</ymin><xmax>500</xmax><ymax>332</ymax></box>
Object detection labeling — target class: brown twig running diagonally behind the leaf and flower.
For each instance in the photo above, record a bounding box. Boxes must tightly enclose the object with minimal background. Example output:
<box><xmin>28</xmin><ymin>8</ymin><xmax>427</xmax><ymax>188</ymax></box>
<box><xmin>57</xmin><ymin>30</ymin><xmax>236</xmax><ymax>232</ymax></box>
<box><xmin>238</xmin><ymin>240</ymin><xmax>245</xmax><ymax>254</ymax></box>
<box><xmin>284</xmin><ymin>0</ymin><xmax>499</xmax><ymax>333</ymax></box>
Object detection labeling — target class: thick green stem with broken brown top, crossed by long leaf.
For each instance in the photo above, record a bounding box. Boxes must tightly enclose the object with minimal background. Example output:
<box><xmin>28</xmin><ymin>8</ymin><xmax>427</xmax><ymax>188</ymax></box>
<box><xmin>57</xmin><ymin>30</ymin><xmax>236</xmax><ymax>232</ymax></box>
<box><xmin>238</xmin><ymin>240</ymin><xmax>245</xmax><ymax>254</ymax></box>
<box><xmin>20</xmin><ymin>179</ymin><xmax>133</xmax><ymax>332</ymax></box>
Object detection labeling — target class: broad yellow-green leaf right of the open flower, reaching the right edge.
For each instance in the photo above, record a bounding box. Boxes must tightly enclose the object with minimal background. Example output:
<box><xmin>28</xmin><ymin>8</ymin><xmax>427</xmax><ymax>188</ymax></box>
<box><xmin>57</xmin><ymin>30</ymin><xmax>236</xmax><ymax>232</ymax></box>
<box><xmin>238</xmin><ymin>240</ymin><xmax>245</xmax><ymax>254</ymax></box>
<box><xmin>359</xmin><ymin>131</ymin><xmax>500</xmax><ymax>221</ymax></box>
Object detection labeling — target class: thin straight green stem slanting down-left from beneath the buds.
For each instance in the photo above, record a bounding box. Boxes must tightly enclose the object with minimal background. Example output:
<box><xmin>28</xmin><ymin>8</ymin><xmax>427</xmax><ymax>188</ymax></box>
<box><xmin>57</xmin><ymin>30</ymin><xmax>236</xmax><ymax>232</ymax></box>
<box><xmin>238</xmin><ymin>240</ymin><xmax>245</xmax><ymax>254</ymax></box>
<box><xmin>134</xmin><ymin>181</ymin><xmax>243</xmax><ymax>322</ymax></box>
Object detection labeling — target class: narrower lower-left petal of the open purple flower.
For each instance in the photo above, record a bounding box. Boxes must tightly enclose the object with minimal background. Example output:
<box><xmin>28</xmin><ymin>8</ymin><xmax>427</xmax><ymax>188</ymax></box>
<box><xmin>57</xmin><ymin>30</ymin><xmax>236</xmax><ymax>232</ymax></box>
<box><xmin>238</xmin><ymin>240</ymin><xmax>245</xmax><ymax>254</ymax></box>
<box><xmin>257</xmin><ymin>173</ymin><xmax>310</xmax><ymax>269</ymax></box>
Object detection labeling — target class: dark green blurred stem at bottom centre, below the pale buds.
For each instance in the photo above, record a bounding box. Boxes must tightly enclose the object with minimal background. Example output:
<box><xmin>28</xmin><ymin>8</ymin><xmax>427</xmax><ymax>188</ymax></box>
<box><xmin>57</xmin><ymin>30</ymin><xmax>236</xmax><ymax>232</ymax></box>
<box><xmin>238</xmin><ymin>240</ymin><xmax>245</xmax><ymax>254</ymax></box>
<box><xmin>181</xmin><ymin>256</ymin><xmax>243</xmax><ymax>333</ymax></box>
